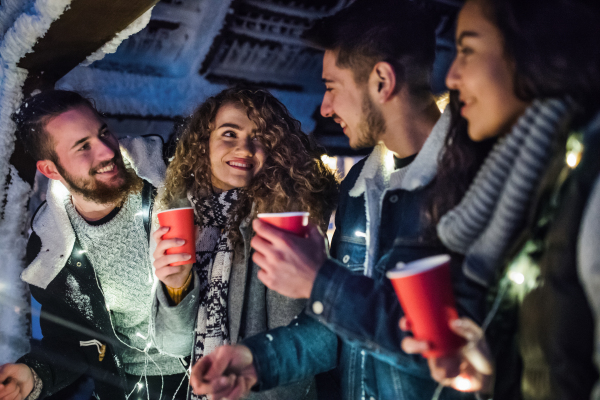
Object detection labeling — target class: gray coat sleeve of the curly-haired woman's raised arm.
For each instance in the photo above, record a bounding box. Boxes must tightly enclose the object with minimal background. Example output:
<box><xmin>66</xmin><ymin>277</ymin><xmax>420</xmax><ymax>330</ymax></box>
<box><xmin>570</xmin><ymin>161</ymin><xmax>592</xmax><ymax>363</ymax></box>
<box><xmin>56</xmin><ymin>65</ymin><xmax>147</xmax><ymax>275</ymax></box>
<box><xmin>152</xmin><ymin>272</ymin><xmax>200</xmax><ymax>357</ymax></box>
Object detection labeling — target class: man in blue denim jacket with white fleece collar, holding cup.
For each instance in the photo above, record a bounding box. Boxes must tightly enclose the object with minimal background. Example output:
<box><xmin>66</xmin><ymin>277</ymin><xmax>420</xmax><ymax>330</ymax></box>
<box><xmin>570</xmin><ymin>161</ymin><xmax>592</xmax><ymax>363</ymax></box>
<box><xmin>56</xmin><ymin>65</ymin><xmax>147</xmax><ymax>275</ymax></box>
<box><xmin>191</xmin><ymin>0</ymin><xmax>479</xmax><ymax>400</ymax></box>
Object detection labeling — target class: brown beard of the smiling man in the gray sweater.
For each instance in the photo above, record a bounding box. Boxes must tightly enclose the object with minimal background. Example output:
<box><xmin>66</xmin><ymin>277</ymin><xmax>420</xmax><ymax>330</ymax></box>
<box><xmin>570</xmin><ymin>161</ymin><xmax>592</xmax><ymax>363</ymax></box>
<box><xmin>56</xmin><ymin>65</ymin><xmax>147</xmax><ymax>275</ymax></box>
<box><xmin>55</xmin><ymin>156</ymin><xmax>143</xmax><ymax>207</ymax></box>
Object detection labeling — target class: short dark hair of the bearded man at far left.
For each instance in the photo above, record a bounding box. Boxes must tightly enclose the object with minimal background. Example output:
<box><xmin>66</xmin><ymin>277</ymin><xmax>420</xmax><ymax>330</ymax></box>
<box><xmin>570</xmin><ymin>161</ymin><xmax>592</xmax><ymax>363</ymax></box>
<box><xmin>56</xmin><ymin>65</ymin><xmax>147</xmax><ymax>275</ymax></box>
<box><xmin>12</xmin><ymin>90</ymin><xmax>99</xmax><ymax>163</ymax></box>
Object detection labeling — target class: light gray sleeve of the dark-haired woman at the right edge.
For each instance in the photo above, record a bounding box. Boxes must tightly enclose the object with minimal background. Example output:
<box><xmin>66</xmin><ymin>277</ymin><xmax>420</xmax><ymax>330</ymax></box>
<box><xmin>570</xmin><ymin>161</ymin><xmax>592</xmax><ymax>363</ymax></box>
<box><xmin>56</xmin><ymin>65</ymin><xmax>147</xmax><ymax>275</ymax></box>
<box><xmin>577</xmin><ymin>176</ymin><xmax>600</xmax><ymax>399</ymax></box>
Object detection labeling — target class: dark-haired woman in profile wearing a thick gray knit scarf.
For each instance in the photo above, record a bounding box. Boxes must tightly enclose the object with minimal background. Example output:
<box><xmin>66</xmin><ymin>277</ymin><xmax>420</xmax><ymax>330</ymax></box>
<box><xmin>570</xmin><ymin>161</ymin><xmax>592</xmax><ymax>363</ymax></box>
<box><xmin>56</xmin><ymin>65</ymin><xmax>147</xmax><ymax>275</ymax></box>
<box><xmin>403</xmin><ymin>0</ymin><xmax>600</xmax><ymax>399</ymax></box>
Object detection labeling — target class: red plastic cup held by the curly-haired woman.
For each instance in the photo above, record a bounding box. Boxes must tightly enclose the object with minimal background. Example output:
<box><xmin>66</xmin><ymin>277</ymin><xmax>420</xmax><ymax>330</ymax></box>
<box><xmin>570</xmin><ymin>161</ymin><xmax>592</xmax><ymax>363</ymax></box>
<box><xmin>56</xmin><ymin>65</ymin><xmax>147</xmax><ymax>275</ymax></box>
<box><xmin>157</xmin><ymin>207</ymin><xmax>196</xmax><ymax>267</ymax></box>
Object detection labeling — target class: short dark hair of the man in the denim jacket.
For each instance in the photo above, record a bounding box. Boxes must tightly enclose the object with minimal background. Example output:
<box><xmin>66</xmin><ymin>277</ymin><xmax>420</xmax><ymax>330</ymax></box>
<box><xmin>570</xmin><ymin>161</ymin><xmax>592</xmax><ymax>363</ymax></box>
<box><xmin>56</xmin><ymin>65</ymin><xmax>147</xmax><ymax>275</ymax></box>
<box><xmin>303</xmin><ymin>0</ymin><xmax>435</xmax><ymax>94</ymax></box>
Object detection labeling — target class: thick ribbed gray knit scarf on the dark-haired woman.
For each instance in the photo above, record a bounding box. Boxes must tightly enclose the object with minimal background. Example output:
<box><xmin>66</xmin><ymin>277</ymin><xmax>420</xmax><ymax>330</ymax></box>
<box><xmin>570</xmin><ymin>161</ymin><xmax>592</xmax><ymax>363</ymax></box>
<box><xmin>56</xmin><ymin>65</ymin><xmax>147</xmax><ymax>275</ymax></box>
<box><xmin>437</xmin><ymin>99</ymin><xmax>572</xmax><ymax>286</ymax></box>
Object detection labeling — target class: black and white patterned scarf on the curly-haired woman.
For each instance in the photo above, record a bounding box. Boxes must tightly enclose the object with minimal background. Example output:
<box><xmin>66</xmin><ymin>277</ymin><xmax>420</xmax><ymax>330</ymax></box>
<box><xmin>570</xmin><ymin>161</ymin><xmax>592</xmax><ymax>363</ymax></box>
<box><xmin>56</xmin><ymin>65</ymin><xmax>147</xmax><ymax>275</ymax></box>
<box><xmin>188</xmin><ymin>189</ymin><xmax>240</xmax><ymax>399</ymax></box>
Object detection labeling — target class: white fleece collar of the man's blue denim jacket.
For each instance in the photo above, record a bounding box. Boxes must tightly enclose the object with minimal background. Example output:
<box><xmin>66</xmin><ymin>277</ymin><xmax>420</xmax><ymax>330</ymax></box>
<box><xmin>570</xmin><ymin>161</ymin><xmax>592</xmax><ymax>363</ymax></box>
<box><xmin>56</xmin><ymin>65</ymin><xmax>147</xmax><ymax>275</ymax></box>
<box><xmin>349</xmin><ymin>108</ymin><xmax>450</xmax><ymax>197</ymax></box>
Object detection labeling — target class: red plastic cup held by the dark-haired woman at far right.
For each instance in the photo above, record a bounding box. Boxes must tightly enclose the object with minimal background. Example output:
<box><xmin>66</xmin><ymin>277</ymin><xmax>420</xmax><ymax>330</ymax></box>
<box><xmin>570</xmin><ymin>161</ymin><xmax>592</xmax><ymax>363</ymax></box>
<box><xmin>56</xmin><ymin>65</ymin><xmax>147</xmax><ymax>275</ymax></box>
<box><xmin>386</xmin><ymin>255</ymin><xmax>465</xmax><ymax>357</ymax></box>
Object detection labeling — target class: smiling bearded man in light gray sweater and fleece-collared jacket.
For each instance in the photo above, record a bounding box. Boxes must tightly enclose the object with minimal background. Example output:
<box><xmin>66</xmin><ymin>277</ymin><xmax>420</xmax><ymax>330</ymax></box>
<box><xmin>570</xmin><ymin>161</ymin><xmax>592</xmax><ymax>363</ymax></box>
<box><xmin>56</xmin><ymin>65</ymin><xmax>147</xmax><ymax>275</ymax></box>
<box><xmin>0</xmin><ymin>90</ymin><xmax>193</xmax><ymax>399</ymax></box>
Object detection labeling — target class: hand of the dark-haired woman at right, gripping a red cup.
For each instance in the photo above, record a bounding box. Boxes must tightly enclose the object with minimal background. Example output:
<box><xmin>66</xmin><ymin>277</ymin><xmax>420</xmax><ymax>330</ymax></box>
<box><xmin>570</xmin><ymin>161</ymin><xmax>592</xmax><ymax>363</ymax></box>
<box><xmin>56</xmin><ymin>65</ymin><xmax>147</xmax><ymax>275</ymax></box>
<box><xmin>400</xmin><ymin>317</ymin><xmax>494</xmax><ymax>394</ymax></box>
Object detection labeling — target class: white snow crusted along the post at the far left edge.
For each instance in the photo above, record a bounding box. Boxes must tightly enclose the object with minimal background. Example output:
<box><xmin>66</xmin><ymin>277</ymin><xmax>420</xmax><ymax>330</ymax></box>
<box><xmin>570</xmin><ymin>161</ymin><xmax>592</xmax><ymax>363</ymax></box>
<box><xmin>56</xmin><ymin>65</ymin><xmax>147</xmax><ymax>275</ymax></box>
<box><xmin>0</xmin><ymin>0</ymin><xmax>71</xmax><ymax>364</ymax></box>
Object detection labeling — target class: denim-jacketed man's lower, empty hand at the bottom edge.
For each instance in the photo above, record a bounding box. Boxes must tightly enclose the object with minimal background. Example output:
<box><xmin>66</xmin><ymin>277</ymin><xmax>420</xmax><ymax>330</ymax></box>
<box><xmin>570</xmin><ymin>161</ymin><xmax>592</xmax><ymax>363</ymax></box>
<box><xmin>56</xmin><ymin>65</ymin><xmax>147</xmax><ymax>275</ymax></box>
<box><xmin>190</xmin><ymin>345</ymin><xmax>258</xmax><ymax>400</ymax></box>
